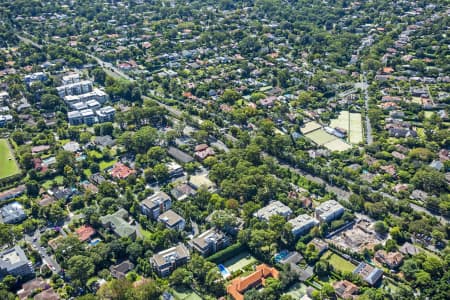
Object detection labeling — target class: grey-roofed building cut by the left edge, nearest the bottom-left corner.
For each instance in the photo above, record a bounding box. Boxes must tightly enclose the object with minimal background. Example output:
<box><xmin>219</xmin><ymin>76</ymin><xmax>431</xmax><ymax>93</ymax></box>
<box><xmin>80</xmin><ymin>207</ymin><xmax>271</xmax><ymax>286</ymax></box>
<box><xmin>0</xmin><ymin>246</ymin><xmax>34</xmax><ymax>278</ymax></box>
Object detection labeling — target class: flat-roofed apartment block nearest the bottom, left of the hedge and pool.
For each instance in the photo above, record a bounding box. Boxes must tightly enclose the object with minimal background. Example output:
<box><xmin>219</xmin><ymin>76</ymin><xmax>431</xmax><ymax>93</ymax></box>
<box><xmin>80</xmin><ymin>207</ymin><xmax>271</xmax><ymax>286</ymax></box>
<box><xmin>150</xmin><ymin>244</ymin><xmax>190</xmax><ymax>277</ymax></box>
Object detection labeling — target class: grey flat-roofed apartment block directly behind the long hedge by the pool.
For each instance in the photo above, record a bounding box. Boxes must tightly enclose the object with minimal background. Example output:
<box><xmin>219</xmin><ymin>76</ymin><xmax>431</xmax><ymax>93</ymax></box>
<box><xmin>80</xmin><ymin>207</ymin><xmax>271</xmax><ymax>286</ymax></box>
<box><xmin>189</xmin><ymin>229</ymin><xmax>231</xmax><ymax>257</ymax></box>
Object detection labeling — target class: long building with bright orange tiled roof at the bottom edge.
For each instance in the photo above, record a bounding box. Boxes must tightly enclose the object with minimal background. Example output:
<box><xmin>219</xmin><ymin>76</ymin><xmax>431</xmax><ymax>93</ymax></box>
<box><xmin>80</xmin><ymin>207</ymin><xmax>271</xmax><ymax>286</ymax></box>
<box><xmin>227</xmin><ymin>264</ymin><xmax>280</xmax><ymax>300</ymax></box>
